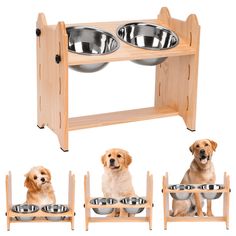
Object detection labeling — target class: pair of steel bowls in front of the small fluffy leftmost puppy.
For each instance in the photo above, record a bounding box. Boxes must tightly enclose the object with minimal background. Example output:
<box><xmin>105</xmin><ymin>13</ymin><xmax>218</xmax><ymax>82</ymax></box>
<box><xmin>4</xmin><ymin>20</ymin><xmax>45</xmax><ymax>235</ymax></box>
<box><xmin>12</xmin><ymin>204</ymin><xmax>69</xmax><ymax>221</ymax></box>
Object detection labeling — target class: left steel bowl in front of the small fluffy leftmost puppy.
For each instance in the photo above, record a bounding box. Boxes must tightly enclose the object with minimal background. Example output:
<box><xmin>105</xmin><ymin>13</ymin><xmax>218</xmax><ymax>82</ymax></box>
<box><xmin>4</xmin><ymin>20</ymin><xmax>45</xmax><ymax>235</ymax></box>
<box><xmin>12</xmin><ymin>204</ymin><xmax>39</xmax><ymax>221</ymax></box>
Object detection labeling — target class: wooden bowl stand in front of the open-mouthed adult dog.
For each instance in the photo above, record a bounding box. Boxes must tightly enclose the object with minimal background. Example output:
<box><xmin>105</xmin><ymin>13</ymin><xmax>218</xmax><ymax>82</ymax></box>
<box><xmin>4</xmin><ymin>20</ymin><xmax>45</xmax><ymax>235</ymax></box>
<box><xmin>163</xmin><ymin>173</ymin><xmax>230</xmax><ymax>229</ymax></box>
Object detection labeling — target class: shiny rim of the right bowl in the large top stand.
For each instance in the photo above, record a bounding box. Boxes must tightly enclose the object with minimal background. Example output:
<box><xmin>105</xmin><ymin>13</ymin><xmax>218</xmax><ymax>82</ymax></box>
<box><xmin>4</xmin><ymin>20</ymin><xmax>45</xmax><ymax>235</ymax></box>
<box><xmin>116</xmin><ymin>21</ymin><xmax>179</xmax><ymax>51</ymax></box>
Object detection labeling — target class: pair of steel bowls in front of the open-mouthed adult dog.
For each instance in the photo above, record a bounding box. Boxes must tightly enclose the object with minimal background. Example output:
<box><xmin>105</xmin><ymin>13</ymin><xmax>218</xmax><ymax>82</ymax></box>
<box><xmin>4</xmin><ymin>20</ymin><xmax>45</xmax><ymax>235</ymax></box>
<box><xmin>169</xmin><ymin>184</ymin><xmax>224</xmax><ymax>200</ymax></box>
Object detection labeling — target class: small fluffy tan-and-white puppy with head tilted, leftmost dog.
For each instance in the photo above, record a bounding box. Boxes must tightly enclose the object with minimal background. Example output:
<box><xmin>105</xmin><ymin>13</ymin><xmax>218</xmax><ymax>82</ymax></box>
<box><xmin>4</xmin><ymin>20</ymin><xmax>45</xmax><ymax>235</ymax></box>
<box><xmin>25</xmin><ymin>166</ymin><xmax>56</xmax><ymax>206</ymax></box>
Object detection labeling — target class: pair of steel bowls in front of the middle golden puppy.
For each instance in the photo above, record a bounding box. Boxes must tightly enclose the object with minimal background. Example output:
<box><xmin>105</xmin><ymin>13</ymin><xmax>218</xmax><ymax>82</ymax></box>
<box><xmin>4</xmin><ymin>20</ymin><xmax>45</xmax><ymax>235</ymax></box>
<box><xmin>90</xmin><ymin>197</ymin><xmax>147</xmax><ymax>215</ymax></box>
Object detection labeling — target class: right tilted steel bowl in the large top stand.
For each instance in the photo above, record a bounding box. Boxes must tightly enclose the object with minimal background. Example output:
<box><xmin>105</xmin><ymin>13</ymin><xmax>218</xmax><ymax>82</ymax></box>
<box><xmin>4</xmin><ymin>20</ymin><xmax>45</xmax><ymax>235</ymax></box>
<box><xmin>117</xmin><ymin>22</ymin><xmax>179</xmax><ymax>65</ymax></box>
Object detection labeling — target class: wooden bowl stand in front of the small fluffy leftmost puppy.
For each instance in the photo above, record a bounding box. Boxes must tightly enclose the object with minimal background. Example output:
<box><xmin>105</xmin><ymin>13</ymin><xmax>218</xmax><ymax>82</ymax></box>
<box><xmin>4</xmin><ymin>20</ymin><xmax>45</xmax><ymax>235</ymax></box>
<box><xmin>6</xmin><ymin>172</ymin><xmax>75</xmax><ymax>231</ymax></box>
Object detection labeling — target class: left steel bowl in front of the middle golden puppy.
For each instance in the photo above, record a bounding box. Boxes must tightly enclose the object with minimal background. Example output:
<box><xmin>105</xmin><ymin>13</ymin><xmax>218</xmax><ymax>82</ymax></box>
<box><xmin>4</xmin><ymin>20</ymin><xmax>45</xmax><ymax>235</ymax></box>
<box><xmin>90</xmin><ymin>198</ymin><xmax>117</xmax><ymax>215</ymax></box>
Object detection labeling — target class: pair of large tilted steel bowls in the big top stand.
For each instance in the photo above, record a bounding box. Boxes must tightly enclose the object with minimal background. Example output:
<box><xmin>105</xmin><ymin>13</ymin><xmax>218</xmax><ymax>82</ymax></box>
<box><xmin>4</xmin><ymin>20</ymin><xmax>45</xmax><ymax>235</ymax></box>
<box><xmin>66</xmin><ymin>22</ymin><xmax>179</xmax><ymax>72</ymax></box>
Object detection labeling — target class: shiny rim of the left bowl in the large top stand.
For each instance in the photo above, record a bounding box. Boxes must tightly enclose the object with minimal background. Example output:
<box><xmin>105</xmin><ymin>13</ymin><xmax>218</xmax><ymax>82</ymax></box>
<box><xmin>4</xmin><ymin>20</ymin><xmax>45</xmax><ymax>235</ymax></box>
<box><xmin>66</xmin><ymin>26</ymin><xmax>120</xmax><ymax>56</ymax></box>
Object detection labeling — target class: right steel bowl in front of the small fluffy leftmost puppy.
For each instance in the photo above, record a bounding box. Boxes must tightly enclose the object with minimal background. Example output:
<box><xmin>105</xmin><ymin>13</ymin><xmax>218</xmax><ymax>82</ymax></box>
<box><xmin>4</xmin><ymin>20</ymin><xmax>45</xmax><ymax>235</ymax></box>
<box><xmin>41</xmin><ymin>204</ymin><xmax>69</xmax><ymax>221</ymax></box>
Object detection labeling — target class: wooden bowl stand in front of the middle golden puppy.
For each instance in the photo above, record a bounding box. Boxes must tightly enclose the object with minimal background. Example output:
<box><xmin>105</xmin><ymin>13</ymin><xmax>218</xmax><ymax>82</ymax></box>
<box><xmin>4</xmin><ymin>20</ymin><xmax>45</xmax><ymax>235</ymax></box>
<box><xmin>84</xmin><ymin>172</ymin><xmax>153</xmax><ymax>231</ymax></box>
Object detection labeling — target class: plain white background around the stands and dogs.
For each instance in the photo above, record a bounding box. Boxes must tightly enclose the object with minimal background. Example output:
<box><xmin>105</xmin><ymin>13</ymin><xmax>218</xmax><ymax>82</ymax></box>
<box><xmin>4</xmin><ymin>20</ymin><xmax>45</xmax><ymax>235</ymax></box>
<box><xmin>0</xmin><ymin>0</ymin><xmax>236</xmax><ymax>235</ymax></box>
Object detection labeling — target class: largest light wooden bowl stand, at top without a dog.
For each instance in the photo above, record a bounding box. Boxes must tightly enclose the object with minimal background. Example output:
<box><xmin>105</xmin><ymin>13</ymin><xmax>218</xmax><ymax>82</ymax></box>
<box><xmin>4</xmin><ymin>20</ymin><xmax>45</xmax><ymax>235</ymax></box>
<box><xmin>36</xmin><ymin>8</ymin><xmax>200</xmax><ymax>151</ymax></box>
